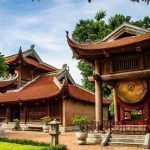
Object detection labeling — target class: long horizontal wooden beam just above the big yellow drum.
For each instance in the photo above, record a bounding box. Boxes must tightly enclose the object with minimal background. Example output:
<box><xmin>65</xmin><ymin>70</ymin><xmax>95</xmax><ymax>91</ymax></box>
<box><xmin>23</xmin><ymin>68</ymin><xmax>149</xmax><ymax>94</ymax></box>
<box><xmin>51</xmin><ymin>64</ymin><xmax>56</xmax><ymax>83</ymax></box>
<box><xmin>101</xmin><ymin>69</ymin><xmax>150</xmax><ymax>81</ymax></box>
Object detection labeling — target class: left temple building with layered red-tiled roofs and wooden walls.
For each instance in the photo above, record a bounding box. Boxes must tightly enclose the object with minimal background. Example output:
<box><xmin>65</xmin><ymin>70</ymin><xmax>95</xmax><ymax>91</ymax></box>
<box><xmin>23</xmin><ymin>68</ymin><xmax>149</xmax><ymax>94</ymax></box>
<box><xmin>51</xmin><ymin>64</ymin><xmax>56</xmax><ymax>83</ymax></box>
<box><xmin>0</xmin><ymin>45</ymin><xmax>111</xmax><ymax>131</ymax></box>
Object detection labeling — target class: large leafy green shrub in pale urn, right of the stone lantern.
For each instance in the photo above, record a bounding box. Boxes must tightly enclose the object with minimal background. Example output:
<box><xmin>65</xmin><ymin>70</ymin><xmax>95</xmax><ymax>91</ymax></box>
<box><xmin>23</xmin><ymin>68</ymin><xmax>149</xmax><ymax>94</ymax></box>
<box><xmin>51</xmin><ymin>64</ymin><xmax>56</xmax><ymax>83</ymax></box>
<box><xmin>72</xmin><ymin>116</ymin><xmax>88</xmax><ymax>145</ymax></box>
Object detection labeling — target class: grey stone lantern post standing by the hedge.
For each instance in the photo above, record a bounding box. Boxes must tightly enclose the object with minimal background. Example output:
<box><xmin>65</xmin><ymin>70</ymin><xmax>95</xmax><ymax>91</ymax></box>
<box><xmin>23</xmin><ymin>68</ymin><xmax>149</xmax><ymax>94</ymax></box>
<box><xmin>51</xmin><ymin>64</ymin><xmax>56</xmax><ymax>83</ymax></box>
<box><xmin>49</xmin><ymin>119</ymin><xmax>60</xmax><ymax>146</ymax></box>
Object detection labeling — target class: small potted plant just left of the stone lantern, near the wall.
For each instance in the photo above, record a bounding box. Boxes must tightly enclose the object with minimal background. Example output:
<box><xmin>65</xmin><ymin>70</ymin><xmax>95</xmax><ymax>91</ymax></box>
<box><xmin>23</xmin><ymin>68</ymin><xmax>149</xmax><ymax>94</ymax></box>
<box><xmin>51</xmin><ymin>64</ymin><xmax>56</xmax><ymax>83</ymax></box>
<box><xmin>41</xmin><ymin>116</ymin><xmax>51</xmax><ymax>133</ymax></box>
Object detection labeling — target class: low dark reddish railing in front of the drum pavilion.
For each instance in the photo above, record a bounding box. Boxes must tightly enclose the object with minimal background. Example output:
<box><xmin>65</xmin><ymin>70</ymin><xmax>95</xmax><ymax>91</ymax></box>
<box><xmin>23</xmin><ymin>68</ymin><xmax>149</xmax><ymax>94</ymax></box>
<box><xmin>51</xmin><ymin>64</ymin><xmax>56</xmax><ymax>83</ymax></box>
<box><xmin>88</xmin><ymin>120</ymin><xmax>150</xmax><ymax>135</ymax></box>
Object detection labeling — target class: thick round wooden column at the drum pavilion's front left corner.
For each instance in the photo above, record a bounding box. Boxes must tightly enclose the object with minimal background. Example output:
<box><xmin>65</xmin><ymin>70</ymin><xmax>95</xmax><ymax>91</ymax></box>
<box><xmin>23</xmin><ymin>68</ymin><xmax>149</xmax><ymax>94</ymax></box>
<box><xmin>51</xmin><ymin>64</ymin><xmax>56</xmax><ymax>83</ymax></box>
<box><xmin>95</xmin><ymin>59</ymin><xmax>103</xmax><ymax>122</ymax></box>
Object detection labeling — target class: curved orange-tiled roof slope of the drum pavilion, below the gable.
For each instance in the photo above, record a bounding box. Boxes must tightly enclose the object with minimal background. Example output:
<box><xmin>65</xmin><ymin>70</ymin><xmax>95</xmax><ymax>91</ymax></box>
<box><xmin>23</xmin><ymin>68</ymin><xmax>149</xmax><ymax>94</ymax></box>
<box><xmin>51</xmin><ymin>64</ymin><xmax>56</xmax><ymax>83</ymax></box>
<box><xmin>68</xmin><ymin>33</ymin><xmax>150</xmax><ymax>55</ymax></box>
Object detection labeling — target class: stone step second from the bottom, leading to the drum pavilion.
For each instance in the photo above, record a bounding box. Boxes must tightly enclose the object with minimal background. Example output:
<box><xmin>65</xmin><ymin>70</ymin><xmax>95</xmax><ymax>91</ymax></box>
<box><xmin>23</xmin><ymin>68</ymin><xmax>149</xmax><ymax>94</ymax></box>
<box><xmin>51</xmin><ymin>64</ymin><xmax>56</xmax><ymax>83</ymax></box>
<box><xmin>109</xmin><ymin>138</ymin><xmax>144</xmax><ymax>143</ymax></box>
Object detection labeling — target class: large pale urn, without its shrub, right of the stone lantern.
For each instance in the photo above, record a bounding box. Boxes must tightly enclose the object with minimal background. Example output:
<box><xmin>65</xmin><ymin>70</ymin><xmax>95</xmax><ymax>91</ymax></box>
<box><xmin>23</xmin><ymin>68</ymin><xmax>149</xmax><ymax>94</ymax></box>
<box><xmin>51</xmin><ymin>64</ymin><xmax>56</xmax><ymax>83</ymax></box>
<box><xmin>76</xmin><ymin>131</ymin><xmax>88</xmax><ymax>145</ymax></box>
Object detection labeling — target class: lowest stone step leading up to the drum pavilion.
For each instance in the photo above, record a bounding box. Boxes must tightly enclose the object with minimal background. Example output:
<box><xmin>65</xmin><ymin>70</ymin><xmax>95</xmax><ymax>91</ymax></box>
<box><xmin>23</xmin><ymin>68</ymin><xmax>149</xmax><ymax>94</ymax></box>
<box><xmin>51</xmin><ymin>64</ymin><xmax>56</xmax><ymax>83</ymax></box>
<box><xmin>108</xmin><ymin>142</ymin><xmax>143</xmax><ymax>147</ymax></box>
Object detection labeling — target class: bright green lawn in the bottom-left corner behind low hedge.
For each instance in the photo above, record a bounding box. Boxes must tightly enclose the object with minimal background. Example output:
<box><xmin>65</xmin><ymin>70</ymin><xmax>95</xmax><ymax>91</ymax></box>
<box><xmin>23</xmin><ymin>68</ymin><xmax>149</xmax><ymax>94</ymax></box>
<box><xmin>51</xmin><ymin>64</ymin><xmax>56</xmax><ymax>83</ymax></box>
<box><xmin>0</xmin><ymin>142</ymin><xmax>46</xmax><ymax>150</ymax></box>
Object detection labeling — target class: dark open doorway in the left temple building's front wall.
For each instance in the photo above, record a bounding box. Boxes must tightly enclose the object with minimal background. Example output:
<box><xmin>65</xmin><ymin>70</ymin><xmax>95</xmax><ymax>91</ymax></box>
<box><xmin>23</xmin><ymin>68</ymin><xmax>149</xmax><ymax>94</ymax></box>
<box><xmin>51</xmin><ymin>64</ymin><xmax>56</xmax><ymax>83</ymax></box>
<box><xmin>10</xmin><ymin>104</ymin><xmax>20</xmax><ymax>122</ymax></box>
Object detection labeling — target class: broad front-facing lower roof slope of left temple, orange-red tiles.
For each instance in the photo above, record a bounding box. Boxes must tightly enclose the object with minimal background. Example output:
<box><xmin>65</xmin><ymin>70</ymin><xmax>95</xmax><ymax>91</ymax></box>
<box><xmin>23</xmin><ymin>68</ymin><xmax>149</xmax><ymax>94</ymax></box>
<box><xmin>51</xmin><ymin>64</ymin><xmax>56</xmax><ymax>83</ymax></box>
<box><xmin>0</xmin><ymin>75</ymin><xmax>61</xmax><ymax>102</ymax></box>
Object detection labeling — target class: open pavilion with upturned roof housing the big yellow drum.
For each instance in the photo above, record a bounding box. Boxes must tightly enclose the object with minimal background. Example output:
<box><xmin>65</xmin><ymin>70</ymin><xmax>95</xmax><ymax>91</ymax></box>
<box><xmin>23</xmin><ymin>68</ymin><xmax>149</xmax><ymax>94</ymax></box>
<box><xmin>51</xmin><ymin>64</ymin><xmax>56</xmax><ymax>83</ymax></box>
<box><xmin>67</xmin><ymin>23</ymin><xmax>150</xmax><ymax>129</ymax></box>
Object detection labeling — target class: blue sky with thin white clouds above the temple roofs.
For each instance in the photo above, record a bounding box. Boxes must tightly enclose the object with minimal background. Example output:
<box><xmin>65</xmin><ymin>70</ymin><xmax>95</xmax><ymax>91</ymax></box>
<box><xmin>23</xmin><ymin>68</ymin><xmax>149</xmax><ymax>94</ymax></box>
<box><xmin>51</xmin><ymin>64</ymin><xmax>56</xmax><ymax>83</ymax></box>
<box><xmin>0</xmin><ymin>0</ymin><xmax>150</xmax><ymax>84</ymax></box>
